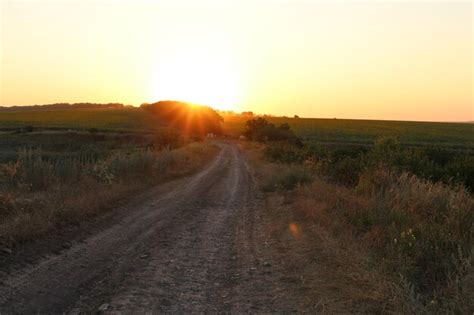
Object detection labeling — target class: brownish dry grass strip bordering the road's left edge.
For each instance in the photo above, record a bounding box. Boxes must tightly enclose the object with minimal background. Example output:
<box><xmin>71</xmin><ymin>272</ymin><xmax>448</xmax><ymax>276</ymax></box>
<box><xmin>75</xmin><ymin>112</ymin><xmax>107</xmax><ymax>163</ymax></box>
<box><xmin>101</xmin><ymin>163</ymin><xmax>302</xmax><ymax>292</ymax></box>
<box><xmin>0</xmin><ymin>143</ymin><xmax>218</xmax><ymax>246</ymax></box>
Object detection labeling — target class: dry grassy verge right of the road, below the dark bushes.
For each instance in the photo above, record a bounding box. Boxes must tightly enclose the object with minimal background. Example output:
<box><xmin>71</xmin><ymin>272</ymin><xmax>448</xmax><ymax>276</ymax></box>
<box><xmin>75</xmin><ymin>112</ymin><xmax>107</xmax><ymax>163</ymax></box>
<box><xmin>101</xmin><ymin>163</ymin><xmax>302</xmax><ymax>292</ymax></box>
<box><xmin>243</xmin><ymin>145</ymin><xmax>474</xmax><ymax>313</ymax></box>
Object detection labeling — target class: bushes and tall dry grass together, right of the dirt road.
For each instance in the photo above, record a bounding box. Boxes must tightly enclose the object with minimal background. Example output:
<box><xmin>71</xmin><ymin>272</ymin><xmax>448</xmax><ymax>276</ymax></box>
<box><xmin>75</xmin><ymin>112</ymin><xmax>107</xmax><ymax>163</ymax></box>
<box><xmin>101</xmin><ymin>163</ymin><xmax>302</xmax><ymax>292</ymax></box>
<box><xmin>245</xmin><ymin>118</ymin><xmax>474</xmax><ymax>313</ymax></box>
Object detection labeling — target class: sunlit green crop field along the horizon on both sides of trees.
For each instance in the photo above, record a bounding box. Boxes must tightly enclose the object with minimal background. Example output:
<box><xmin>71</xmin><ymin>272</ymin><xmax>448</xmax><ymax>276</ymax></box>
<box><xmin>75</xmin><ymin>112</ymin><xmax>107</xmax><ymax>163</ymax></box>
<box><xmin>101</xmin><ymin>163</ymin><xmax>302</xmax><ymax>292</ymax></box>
<box><xmin>0</xmin><ymin>108</ymin><xmax>474</xmax><ymax>150</ymax></box>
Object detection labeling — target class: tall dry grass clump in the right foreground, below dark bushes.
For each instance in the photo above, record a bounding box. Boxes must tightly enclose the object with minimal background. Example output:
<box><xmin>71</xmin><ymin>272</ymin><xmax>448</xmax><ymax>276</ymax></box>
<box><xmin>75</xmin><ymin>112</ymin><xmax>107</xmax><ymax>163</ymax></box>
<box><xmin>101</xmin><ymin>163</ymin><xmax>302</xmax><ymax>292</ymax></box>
<box><xmin>294</xmin><ymin>169</ymin><xmax>474</xmax><ymax>313</ymax></box>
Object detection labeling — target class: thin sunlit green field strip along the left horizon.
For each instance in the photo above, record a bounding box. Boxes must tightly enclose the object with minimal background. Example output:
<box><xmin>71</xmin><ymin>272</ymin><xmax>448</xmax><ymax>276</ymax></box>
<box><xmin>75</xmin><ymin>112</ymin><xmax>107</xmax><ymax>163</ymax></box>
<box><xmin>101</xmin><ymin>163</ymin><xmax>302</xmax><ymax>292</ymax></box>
<box><xmin>0</xmin><ymin>108</ymin><xmax>160</xmax><ymax>131</ymax></box>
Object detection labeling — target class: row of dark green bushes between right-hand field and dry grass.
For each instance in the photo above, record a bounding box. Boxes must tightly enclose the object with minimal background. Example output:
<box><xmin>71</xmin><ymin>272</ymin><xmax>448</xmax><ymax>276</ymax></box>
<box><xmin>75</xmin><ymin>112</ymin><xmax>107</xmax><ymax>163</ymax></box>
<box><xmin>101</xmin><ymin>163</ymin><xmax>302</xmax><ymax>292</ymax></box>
<box><xmin>260</xmin><ymin>135</ymin><xmax>474</xmax><ymax>192</ymax></box>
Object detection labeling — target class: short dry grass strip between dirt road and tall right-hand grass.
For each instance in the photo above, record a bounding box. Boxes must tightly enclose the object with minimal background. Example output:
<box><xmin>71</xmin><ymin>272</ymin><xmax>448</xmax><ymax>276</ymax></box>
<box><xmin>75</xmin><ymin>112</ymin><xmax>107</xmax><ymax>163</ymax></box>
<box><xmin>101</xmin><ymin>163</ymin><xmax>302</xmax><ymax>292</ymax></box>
<box><xmin>263</xmin><ymin>182</ymin><xmax>413</xmax><ymax>314</ymax></box>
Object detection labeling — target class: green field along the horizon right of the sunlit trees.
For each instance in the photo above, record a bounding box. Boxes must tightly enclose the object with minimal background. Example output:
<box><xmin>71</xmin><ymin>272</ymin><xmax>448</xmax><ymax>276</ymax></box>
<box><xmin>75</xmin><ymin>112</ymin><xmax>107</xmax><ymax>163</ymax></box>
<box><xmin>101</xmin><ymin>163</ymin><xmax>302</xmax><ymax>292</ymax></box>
<box><xmin>224</xmin><ymin>116</ymin><xmax>474</xmax><ymax>149</ymax></box>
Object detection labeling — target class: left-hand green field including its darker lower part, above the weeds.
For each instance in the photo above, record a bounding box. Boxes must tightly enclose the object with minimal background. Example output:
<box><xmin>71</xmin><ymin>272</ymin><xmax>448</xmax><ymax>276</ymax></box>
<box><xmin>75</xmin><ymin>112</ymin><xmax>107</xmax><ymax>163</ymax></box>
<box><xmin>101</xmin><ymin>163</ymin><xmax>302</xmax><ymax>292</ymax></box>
<box><xmin>0</xmin><ymin>108</ymin><xmax>177</xmax><ymax>162</ymax></box>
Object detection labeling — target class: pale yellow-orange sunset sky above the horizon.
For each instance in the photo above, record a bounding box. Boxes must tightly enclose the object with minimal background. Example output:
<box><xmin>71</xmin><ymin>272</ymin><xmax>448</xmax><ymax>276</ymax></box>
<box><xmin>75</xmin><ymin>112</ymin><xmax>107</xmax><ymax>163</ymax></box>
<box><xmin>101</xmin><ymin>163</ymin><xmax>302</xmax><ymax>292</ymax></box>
<box><xmin>0</xmin><ymin>0</ymin><xmax>474</xmax><ymax>121</ymax></box>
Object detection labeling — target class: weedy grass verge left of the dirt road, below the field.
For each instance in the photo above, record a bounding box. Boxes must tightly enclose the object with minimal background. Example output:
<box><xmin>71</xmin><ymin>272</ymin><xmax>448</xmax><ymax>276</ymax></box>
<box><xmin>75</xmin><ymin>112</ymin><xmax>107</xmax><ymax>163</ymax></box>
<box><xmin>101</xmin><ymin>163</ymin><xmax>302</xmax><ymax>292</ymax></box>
<box><xmin>0</xmin><ymin>143</ymin><xmax>218</xmax><ymax>246</ymax></box>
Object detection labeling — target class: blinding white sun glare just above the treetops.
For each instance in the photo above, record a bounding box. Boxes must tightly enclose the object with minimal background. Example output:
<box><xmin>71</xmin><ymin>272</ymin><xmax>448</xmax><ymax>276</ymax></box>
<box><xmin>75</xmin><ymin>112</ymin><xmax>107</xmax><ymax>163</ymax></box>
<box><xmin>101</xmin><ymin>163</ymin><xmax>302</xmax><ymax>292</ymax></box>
<box><xmin>152</xmin><ymin>33</ymin><xmax>240</xmax><ymax>110</ymax></box>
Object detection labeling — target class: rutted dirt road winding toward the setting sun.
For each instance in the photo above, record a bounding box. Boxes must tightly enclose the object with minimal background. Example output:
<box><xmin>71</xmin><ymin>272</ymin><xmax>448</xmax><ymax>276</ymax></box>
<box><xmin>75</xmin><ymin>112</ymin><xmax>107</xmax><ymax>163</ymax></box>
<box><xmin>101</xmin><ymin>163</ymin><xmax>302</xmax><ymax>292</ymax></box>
<box><xmin>0</xmin><ymin>143</ymin><xmax>286</xmax><ymax>314</ymax></box>
